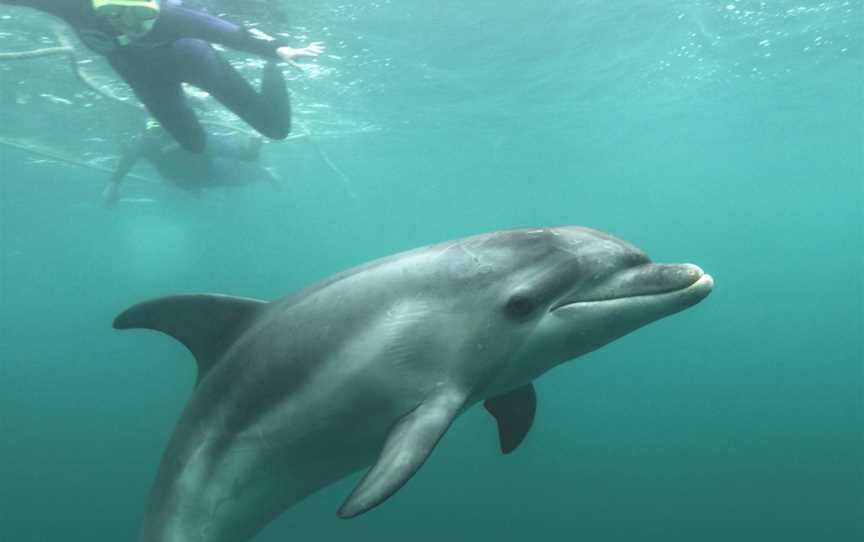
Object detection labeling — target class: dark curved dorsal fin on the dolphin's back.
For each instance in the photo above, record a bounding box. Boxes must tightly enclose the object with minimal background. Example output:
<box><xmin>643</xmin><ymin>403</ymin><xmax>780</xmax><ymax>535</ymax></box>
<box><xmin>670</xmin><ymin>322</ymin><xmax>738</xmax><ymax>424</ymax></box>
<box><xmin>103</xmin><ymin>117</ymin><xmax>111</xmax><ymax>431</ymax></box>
<box><xmin>114</xmin><ymin>294</ymin><xmax>267</xmax><ymax>385</ymax></box>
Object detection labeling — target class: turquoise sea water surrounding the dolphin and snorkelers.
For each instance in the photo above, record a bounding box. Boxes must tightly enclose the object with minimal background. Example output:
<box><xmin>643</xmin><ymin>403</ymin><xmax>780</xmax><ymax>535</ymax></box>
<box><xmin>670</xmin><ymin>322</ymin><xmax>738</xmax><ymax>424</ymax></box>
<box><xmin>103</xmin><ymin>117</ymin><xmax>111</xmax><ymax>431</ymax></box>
<box><xmin>0</xmin><ymin>0</ymin><xmax>864</xmax><ymax>542</ymax></box>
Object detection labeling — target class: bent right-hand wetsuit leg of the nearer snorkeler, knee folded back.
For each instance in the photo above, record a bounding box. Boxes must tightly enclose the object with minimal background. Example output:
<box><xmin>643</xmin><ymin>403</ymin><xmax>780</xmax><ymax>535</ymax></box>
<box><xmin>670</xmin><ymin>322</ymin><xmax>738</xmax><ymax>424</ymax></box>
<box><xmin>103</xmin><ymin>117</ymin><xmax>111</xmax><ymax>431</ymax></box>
<box><xmin>173</xmin><ymin>39</ymin><xmax>291</xmax><ymax>139</ymax></box>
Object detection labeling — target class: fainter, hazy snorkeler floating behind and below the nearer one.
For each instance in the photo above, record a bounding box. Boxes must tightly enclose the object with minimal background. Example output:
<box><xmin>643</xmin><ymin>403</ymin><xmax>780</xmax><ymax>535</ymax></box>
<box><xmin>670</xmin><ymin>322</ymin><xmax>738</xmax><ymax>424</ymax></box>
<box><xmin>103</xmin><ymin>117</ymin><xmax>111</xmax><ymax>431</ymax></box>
<box><xmin>102</xmin><ymin>120</ymin><xmax>279</xmax><ymax>206</ymax></box>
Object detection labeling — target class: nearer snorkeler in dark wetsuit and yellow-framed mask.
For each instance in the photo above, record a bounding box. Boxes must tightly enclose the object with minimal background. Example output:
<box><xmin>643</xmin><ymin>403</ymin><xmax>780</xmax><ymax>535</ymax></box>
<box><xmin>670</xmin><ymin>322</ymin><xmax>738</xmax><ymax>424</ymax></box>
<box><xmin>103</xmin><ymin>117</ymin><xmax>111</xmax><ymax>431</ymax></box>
<box><xmin>0</xmin><ymin>0</ymin><xmax>324</xmax><ymax>152</ymax></box>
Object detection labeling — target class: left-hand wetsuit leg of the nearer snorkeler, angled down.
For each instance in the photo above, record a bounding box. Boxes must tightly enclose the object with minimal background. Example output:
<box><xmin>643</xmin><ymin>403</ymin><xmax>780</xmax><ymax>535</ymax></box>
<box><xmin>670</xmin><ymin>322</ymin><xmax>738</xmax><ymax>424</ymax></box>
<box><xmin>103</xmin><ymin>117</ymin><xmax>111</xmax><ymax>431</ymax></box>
<box><xmin>108</xmin><ymin>57</ymin><xmax>207</xmax><ymax>153</ymax></box>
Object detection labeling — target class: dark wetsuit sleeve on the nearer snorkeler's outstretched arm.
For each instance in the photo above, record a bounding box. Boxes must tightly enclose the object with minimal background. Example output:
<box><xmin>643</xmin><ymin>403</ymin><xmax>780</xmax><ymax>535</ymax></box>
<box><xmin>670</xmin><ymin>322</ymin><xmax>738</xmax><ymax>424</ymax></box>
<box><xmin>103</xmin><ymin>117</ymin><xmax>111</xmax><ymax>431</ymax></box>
<box><xmin>160</xmin><ymin>5</ymin><xmax>286</xmax><ymax>59</ymax></box>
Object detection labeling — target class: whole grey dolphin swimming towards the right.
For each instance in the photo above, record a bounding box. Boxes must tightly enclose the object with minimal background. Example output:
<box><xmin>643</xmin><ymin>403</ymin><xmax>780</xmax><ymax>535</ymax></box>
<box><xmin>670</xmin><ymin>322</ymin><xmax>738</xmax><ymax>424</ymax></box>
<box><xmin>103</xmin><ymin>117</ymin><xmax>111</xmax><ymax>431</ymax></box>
<box><xmin>114</xmin><ymin>226</ymin><xmax>713</xmax><ymax>542</ymax></box>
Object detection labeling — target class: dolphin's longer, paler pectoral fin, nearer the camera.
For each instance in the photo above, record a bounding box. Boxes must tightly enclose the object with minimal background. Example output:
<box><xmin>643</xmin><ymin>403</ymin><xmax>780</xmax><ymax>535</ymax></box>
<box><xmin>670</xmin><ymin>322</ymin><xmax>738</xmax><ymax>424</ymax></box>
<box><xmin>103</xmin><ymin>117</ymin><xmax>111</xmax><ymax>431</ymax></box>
<box><xmin>338</xmin><ymin>394</ymin><xmax>465</xmax><ymax>518</ymax></box>
